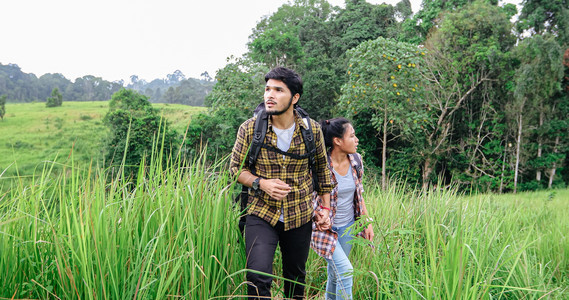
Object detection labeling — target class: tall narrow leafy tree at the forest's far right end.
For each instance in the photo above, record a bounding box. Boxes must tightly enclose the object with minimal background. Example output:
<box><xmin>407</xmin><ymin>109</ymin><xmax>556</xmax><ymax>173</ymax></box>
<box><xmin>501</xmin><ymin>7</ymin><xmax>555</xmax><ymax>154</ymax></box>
<box><xmin>513</xmin><ymin>35</ymin><xmax>566</xmax><ymax>188</ymax></box>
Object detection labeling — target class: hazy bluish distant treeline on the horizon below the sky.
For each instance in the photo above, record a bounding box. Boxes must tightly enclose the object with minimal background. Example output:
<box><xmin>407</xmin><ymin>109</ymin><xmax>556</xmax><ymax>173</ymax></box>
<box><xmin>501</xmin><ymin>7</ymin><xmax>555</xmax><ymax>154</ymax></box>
<box><xmin>0</xmin><ymin>63</ymin><xmax>214</xmax><ymax>106</ymax></box>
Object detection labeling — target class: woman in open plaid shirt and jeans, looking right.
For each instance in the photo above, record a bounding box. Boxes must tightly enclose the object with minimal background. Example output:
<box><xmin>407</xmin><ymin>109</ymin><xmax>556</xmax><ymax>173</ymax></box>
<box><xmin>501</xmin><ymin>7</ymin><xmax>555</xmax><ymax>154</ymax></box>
<box><xmin>311</xmin><ymin>118</ymin><xmax>374</xmax><ymax>300</ymax></box>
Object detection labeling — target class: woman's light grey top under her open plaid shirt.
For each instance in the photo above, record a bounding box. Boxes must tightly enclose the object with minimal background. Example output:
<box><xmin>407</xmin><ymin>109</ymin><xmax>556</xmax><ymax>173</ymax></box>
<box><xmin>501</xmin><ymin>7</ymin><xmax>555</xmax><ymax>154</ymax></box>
<box><xmin>334</xmin><ymin>165</ymin><xmax>356</xmax><ymax>227</ymax></box>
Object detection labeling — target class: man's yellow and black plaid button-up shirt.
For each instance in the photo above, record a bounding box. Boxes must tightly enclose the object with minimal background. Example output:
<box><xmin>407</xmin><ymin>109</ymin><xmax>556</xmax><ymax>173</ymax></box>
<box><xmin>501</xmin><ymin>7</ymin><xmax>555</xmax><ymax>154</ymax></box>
<box><xmin>230</xmin><ymin>112</ymin><xmax>333</xmax><ymax>230</ymax></box>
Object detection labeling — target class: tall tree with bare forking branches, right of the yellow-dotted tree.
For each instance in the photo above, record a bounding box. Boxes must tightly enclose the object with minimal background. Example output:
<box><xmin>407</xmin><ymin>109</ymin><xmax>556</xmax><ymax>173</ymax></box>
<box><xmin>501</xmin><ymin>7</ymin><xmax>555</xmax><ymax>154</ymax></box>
<box><xmin>414</xmin><ymin>1</ymin><xmax>515</xmax><ymax>187</ymax></box>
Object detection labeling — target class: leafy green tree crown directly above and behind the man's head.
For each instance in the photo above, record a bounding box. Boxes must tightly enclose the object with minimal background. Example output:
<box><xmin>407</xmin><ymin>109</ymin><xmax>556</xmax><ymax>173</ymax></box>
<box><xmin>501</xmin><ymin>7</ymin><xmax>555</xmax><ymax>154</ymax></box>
<box><xmin>246</xmin><ymin>0</ymin><xmax>336</xmax><ymax>120</ymax></box>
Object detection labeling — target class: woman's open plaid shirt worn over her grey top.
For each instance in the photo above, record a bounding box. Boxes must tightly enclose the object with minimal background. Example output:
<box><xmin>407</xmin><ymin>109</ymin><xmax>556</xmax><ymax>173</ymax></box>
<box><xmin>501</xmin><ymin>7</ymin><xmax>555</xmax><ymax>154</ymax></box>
<box><xmin>310</xmin><ymin>153</ymin><xmax>364</xmax><ymax>259</ymax></box>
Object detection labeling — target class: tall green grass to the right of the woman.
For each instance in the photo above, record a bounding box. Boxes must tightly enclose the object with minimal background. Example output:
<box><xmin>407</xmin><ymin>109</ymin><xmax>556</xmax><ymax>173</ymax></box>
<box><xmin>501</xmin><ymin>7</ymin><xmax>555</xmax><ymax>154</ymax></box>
<box><xmin>351</xmin><ymin>184</ymin><xmax>569</xmax><ymax>299</ymax></box>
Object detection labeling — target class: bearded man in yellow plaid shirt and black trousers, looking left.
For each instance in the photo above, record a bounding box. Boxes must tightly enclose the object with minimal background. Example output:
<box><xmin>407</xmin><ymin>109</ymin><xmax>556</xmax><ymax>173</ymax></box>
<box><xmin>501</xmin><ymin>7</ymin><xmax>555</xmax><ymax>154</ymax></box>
<box><xmin>230</xmin><ymin>67</ymin><xmax>332</xmax><ymax>299</ymax></box>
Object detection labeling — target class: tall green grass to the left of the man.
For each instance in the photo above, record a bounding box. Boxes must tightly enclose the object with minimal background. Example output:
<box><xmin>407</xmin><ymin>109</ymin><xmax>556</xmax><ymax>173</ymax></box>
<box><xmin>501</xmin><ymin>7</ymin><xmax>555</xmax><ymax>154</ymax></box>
<box><xmin>0</xmin><ymin>149</ymin><xmax>245</xmax><ymax>299</ymax></box>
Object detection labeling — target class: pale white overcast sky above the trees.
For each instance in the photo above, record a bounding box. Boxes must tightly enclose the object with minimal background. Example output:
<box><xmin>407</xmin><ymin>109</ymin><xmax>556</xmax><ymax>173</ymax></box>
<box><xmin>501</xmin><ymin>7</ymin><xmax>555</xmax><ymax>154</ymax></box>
<box><xmin>0</xmin><ymin>0</ymin><xmax>516</xmax><ymax>83</ymax></box>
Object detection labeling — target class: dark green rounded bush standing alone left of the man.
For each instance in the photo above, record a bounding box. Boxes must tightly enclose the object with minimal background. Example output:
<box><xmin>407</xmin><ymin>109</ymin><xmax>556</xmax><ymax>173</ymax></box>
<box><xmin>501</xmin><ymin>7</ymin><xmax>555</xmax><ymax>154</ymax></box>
<box><xmin>104</xmin><ymin>89</ymin><xmax>178</xmax><ymax>176</ymax></box>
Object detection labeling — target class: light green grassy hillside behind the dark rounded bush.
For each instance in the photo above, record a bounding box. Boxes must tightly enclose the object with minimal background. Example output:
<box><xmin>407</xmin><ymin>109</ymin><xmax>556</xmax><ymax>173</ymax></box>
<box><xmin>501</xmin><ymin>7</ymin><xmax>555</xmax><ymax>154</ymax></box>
<box><xmin>0</xmin><ymin>101</ymin><xmax>205</xmax><ymax>183</ymax></box>
